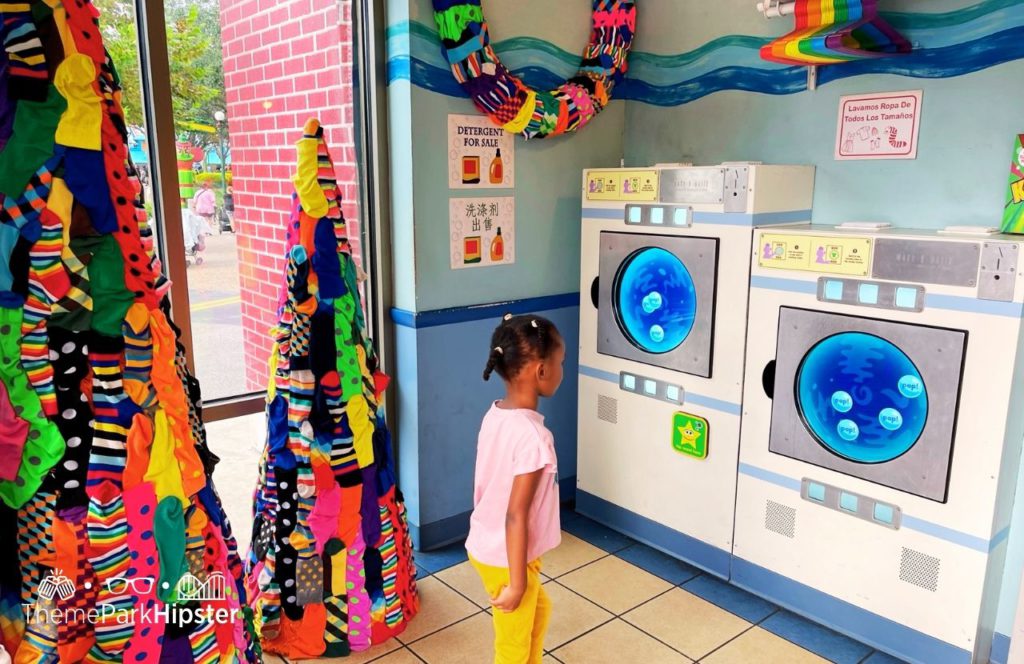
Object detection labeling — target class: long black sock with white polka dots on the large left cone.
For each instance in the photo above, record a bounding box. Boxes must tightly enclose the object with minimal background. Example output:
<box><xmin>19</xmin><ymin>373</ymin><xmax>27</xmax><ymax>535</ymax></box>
<box><xmin>49</xmin><ymin>326</ymin><xmax>92</xmax><ymax>509</ymax></box>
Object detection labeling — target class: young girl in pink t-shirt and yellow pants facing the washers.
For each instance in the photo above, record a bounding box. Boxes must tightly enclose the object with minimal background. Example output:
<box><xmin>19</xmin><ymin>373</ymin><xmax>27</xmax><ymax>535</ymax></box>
<box><xmin>466</xmin><ymin>315</ymin><xmax>565</xmax><ymax>664</ymax></box>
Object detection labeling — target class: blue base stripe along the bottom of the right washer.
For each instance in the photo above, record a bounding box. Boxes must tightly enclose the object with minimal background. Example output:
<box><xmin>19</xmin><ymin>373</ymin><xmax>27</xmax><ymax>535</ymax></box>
<box><xmin>732</xmin><ymin>557</ymin><xmax>971</xmax><ymax>664</ymax></box>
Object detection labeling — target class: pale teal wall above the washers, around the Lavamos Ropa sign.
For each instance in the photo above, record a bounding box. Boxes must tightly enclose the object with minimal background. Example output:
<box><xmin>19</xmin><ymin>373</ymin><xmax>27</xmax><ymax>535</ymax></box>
<box><xmin>625</xmin><ymin>0</ymin><xmax>1024</xmax><ymax>229</ymax></box>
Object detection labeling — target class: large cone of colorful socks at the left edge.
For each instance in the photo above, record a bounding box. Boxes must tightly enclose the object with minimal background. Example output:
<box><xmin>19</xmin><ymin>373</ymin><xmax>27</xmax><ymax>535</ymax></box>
<box><xmin>0</xmin><ymin>0</ymin><xmax>256</xmax><ymax>664</ymax></box>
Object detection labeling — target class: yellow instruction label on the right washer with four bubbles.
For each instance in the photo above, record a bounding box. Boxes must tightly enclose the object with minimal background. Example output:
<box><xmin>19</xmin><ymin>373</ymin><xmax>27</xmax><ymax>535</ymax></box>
<box><xmin>758</xmin><ymin>233</ymin><xmax>871</xmax><ymax>277</ymax></box>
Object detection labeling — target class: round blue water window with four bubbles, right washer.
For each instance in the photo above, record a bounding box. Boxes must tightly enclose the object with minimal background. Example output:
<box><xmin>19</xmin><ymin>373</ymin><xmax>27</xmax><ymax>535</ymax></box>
<box><xmin>797</xmin><ymin>332</ymin><xmax>928</xmax><ymax>463</ymax></box>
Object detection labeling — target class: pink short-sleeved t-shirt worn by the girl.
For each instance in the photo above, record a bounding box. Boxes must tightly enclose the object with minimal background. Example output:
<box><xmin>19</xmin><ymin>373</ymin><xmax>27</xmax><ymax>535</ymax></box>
<box><xmin>466</xmin><ymin>404</ymin><xmax>562</xmax><ymax>568</ymax></box>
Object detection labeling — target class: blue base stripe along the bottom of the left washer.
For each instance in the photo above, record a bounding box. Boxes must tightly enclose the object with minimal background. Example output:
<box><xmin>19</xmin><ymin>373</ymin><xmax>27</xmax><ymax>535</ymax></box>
<box><xmin>575</xmin><ymin>489</ymin><xmax>732</xmax><ymax>579</ymax></box>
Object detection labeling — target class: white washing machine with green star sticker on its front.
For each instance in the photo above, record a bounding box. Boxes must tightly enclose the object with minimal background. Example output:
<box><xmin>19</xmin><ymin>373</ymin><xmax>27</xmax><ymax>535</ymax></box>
<box><xmin>577</xmin><ymin>164</ymin><xmax>814</xmax><ymax>577</ymax></box>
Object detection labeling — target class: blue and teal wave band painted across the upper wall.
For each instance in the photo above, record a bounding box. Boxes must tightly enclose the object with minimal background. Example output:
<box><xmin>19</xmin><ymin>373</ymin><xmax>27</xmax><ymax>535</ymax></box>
<box><xmin>388</xmin><ymin>0</ymin><xmax>1024</xmax><ymax>107</ymax></box>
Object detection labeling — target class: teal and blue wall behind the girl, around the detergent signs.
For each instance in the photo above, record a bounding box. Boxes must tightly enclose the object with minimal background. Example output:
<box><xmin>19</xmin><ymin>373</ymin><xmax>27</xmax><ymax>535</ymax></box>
<box><xmin>387</xmin><ymin>0</ymin><xmax>626</xmax><ymax>548</ymax></box>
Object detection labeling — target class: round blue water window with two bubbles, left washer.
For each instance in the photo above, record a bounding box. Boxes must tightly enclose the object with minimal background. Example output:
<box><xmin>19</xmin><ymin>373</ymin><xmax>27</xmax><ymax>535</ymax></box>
<box><xmin>614</xmin><ymin>247</ymin><xmax>697</xmax><ymax>354</ymax></box>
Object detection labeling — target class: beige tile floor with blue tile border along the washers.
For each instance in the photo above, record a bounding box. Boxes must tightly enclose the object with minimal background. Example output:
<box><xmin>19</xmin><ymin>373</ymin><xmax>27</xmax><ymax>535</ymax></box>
<box><xmin>260</xmin><ymin>511</ymin><xmax>899</xmax><ymax>664</ymax></box>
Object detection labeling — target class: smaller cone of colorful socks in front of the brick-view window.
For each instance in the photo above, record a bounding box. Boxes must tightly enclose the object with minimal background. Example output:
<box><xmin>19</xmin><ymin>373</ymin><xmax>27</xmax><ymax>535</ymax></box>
<box><xmin>246</xmin><ymin>120</ymin><xmax>419</xmax><ymax>659</ymax></box>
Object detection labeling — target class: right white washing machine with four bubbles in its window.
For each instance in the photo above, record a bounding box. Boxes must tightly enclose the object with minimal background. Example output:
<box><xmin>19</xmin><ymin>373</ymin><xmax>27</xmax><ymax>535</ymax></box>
<box><xmin>732</xmin><ymin>223</ymin><xmax>1024</xmax><ymax>664</ymax></box>
